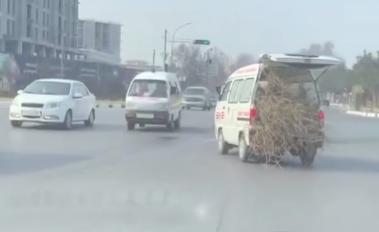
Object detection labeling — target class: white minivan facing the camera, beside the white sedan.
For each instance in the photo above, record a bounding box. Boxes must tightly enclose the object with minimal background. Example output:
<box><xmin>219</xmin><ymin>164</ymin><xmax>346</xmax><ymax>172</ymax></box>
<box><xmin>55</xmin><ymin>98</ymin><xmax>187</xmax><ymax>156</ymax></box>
<box><xmin>125</xmin><ymin>72</ymin><xmax>182</xmax><ymax>130</ymax></box>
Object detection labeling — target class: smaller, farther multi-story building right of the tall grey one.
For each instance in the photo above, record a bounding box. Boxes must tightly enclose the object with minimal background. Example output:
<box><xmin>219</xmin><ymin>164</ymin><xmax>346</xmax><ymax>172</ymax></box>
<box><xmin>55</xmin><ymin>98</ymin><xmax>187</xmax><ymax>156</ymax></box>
<box><xmin>78</xmin><ymin>19</ymin><xmax>121</xmax><ymax>63</ymax></box>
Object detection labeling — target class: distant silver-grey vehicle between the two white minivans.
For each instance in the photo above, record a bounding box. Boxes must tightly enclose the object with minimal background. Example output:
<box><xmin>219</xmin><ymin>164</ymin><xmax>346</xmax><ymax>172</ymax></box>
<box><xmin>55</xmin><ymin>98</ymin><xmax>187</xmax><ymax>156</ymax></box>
<box><xmin>183</xmin><ymin>86</ymin><xmax>212</xmax><ymax>110</ymax></box>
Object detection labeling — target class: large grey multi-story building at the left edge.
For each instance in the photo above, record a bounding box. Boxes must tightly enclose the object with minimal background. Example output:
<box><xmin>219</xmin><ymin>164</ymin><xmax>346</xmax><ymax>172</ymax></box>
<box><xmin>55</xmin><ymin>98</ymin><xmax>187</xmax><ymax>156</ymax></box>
<box><xmin>0</xmin><ymin>0</ymin><xmax>79</xmax><ymax>57</ymax></box>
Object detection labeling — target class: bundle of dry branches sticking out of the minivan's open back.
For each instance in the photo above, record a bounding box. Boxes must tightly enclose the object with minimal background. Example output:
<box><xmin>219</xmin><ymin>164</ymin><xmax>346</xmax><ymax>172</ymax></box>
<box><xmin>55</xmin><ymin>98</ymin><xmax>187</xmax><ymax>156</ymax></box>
<box><xmin>251</xmin><ymin>73</ymin><xmax>320</xmax><ymax>163</ymax></box>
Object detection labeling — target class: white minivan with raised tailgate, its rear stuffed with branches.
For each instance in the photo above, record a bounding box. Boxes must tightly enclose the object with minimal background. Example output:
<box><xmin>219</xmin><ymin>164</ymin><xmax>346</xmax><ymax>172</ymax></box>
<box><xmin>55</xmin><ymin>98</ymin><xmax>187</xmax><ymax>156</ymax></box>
<box><xmin>215</xmin><ymin>54</ymin><xmax>341</xmax><ymax>166</ymax></box>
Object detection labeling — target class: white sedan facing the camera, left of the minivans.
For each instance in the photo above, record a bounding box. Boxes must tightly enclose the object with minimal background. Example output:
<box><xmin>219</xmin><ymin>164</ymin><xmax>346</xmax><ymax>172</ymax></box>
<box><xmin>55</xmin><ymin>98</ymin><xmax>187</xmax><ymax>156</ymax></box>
<box><xmin>9</xmin><ymin>79</ymin><xmax>96</xmax><ymax>129</ymax></box>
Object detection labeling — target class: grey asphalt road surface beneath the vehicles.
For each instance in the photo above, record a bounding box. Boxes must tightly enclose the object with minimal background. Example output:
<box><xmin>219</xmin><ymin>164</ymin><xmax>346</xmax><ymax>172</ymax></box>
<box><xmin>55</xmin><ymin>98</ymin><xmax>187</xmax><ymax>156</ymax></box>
<box><xmin>0</xmin><ymin>109</ymin><xmax>379</xmax><ymax>232</ymax></box>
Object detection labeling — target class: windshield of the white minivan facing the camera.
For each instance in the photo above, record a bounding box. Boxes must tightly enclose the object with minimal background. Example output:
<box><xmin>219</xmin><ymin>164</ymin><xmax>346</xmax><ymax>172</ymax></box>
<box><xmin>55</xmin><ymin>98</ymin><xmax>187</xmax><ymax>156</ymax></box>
<box><xmin>128</xmin><ymin>80</ymin><xmax>168</xmax><ymax>98</ymax></box>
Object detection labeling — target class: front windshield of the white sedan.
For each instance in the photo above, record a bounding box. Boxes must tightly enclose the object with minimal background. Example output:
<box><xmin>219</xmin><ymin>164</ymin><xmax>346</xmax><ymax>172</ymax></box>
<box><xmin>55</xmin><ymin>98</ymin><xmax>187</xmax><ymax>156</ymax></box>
<box><xmin>24</xmin><ymin>81</ymin><xmax>71</xmax><ymax>95</ymax></box>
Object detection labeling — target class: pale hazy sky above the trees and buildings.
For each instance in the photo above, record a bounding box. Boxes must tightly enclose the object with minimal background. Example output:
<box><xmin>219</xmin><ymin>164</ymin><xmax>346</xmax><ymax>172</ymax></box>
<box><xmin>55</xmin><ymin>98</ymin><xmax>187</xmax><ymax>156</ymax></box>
<box><xmin>79</xmin><ymin>0</ymin><xmax>379</xmax><ymax>66</ymax></box>
